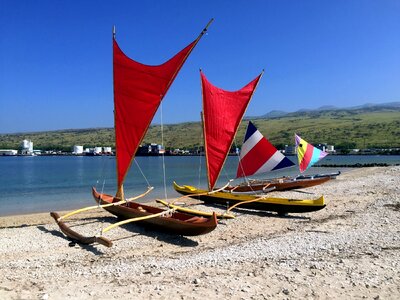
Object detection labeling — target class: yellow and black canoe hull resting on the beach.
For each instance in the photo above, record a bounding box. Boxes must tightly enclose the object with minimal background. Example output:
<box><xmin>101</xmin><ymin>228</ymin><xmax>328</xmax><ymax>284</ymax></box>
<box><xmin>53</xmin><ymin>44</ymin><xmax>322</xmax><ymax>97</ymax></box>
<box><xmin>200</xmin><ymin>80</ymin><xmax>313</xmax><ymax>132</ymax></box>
<box><xmin>174</xmin><ymin>182</ymin><xmax>326</xmax><ymax>214</ymax></box>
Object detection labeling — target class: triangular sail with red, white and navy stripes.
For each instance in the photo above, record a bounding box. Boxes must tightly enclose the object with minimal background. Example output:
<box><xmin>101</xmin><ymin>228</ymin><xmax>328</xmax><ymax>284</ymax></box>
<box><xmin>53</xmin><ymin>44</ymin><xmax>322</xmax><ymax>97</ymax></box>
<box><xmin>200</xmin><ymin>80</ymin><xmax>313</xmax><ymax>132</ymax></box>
<box><xmin>236</xmin><ymin>122</ymin><xmax>295</xmax><ymax>178</ymax></box>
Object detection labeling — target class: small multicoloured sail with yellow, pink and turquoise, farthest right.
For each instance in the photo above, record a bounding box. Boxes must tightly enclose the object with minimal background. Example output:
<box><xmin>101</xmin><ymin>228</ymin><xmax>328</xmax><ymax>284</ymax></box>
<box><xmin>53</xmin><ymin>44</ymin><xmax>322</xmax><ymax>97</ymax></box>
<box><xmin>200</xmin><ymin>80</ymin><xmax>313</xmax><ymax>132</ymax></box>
<box><xmin>295</xmin><ymin>134</ymin><xmax>328</xmax><ymax>173</ymax></box>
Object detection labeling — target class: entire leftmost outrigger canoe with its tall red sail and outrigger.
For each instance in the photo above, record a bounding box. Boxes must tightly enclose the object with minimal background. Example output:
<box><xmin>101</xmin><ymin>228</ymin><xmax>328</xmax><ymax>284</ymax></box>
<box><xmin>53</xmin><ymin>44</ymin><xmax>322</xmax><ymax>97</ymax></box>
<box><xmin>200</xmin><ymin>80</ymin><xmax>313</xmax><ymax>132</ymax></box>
<box><xmin>51</xmin><ymin>19</ymin><xmax>217</xmax><ymax>247</ymax></box>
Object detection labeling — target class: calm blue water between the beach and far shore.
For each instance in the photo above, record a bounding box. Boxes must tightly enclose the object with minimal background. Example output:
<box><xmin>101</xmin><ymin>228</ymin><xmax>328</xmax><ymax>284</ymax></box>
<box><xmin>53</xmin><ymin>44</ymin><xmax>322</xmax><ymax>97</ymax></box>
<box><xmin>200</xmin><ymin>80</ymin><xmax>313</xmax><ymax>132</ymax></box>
<box><xmin>0</xmin><ymin>156</ymin><xmax>400</xmax><ymax>216</ymax></box>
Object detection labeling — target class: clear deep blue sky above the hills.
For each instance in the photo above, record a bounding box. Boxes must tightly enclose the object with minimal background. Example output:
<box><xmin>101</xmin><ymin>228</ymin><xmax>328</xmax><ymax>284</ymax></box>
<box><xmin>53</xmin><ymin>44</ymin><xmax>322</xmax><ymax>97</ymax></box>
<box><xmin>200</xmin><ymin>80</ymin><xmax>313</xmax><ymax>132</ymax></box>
<box><xmin>0</xmin><ymin>0</ymin><xmax>400</xmax><ymax>133</ymax></box>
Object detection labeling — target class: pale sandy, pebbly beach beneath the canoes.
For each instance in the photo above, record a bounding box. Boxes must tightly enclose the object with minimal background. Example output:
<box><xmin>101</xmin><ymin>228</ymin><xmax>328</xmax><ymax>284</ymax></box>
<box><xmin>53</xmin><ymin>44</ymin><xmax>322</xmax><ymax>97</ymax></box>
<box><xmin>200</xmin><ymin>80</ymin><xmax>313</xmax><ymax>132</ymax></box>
<box><xmin>0</xmin><ymin>166</ymin><xmax>400</xmax><ymax>299</ymax></box>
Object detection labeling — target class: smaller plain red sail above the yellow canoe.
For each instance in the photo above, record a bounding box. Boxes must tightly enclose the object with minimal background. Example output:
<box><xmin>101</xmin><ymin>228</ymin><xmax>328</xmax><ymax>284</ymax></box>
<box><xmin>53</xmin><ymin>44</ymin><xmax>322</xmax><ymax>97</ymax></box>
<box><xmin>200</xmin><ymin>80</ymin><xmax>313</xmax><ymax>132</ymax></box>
<box><xmin>201</xmin><ymin>72</ymin><xmax>262</xmax><ymax>190</ymax></box>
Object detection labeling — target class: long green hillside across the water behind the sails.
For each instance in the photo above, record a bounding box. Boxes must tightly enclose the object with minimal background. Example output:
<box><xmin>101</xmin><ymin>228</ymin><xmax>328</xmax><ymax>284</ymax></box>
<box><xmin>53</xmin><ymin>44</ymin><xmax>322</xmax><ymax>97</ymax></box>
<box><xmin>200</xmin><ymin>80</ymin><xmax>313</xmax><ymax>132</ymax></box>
<box><xmin>0</xmin><ymin>107</ymin><xmax>400</xmax><ymax>151</ymax></box>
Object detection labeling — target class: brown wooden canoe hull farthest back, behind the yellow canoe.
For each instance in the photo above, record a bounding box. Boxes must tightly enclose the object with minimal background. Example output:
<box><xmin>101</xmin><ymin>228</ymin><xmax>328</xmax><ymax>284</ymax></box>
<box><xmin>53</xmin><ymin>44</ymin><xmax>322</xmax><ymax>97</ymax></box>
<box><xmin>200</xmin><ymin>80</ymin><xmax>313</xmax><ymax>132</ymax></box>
<box><xmin>226</xmin><ymin>172</ymin><xmax>340</xmax><ymax>193</ymax></box>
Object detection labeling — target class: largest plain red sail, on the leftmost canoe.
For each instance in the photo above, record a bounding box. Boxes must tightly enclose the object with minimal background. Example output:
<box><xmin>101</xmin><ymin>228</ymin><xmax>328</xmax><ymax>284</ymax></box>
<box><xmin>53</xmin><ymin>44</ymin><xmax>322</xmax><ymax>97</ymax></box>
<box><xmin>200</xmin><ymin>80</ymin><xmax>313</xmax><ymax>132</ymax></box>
<box><xmin>113</xmin><ymin>39</ymin><xmax>199</xmax><ymax>186</ymax></box>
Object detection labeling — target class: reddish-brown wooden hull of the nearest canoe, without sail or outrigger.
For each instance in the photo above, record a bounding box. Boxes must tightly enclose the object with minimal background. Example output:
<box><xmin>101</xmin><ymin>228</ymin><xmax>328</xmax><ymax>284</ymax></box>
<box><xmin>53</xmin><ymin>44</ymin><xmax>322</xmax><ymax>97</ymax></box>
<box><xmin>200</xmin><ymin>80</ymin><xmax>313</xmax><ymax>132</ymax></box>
<box><xmin>92</xmin><ymin>188</ymin><xmax>217</xmax><ymax>236</ymax></box>
